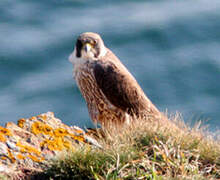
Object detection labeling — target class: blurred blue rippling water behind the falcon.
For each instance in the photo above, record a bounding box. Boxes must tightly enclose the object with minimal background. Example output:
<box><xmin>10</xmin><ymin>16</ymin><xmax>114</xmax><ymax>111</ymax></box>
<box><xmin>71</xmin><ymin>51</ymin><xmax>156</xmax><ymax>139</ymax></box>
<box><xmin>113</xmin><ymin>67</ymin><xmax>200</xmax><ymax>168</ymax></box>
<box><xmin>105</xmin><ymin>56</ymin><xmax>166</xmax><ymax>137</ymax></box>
<box><xmin>0</xmin><ymin>0</ymin><xmax>220</xmax><ymax>131</ymax></box>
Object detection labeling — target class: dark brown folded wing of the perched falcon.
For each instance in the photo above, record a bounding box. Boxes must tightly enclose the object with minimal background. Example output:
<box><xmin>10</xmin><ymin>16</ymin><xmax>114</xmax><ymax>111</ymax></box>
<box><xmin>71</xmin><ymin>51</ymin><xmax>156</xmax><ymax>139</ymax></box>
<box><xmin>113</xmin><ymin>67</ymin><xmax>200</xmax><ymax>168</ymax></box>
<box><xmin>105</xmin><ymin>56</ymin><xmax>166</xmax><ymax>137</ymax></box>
<box><xmin>93</xmin><ymin>61</ymin><xmax>147</xmax><ymax>115</ymax></box>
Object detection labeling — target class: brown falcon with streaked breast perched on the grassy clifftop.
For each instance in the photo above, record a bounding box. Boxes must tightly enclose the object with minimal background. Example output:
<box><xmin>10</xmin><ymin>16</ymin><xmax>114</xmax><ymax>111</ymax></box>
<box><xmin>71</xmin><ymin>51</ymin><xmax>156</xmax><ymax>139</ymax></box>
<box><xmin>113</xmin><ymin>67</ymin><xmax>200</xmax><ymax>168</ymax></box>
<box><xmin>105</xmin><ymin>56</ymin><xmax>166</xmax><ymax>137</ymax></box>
<box><xmin>69</xmin><ymin>32</ymin><xmax>161</xmax><ymax>126</ymax></box>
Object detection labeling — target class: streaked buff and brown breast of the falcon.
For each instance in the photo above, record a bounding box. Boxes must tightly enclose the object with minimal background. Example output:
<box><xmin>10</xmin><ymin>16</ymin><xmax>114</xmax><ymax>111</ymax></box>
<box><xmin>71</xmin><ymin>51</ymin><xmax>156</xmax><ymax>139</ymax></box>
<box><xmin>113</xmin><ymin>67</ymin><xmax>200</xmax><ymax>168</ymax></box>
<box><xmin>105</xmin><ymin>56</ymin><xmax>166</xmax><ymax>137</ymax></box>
<box><xmin>74</xmin><ymin>65</ymin><xmax>125</xmax><ymax>122</ymax></box>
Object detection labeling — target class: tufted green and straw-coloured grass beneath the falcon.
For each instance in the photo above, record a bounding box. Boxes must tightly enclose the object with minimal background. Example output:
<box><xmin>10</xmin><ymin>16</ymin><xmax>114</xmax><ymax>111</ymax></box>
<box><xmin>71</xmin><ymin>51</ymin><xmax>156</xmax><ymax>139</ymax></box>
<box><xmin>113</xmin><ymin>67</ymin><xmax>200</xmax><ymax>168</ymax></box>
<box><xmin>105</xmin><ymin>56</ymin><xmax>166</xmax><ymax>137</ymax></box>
<box><xmin>34</xmin><ymin>115</ymin><xmax>220</xmax><ymax>180</ymax></box>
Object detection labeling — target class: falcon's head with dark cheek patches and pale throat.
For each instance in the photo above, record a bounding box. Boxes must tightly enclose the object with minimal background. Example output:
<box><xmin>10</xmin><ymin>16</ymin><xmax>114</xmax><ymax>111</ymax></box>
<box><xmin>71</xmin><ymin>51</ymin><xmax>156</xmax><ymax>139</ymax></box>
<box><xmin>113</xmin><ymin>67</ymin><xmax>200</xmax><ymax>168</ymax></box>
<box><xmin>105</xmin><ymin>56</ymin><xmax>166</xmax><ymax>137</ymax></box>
<box><xmin>69</xmin><ymin>32</ymin><xmax>106</xmax><ymax>63</ymax></box>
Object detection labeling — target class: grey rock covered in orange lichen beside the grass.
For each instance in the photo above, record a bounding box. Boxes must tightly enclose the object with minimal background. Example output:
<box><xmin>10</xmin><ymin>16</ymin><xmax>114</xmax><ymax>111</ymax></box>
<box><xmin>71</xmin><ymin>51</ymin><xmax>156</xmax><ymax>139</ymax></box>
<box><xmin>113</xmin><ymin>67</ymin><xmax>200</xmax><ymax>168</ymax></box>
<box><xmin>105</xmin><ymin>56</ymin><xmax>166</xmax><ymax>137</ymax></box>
<box><xmin>0</xmin><ymin>112</ymin><xmax>101</xmax><ymax>179</ymax></box>
